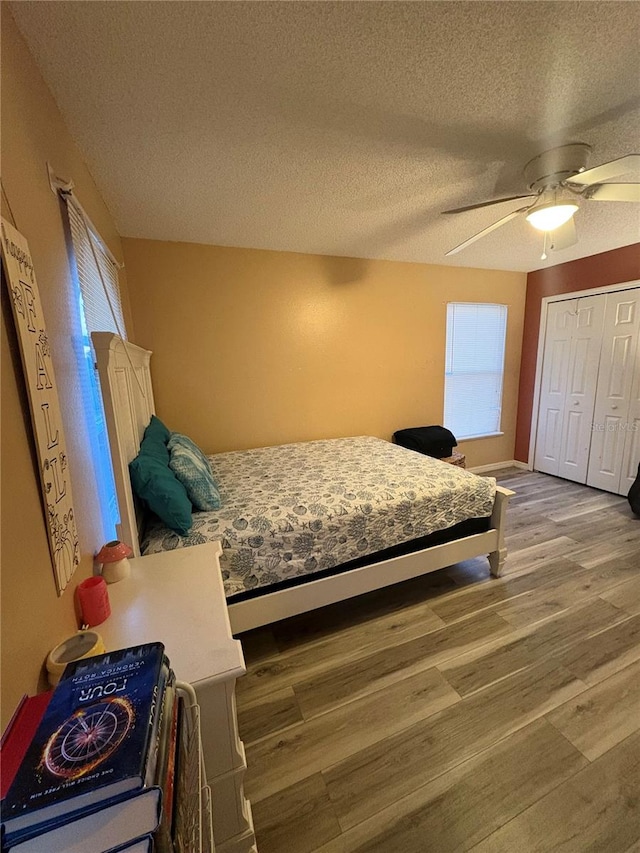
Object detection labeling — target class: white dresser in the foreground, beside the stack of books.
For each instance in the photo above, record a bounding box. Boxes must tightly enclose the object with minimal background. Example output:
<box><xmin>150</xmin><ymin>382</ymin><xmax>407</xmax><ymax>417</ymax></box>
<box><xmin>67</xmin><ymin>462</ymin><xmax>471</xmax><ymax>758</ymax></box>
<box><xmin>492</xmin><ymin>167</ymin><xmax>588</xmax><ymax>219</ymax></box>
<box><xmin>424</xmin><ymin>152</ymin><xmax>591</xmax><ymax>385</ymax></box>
<box><xmin>97</xmin><ymin>543</ymin><xmax>257</xmax><ymax>853</ymax></box>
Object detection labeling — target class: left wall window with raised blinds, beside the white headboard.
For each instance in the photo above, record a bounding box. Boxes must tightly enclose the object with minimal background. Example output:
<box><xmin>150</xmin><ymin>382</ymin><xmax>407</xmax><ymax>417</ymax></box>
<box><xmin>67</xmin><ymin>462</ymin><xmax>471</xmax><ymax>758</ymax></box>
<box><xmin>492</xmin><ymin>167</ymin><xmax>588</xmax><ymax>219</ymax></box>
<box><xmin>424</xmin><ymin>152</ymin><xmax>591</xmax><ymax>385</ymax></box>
<box><xmin>62</xmin><ymin>193</ymin><xmax>126</xmax><ymax>541</ymax></box>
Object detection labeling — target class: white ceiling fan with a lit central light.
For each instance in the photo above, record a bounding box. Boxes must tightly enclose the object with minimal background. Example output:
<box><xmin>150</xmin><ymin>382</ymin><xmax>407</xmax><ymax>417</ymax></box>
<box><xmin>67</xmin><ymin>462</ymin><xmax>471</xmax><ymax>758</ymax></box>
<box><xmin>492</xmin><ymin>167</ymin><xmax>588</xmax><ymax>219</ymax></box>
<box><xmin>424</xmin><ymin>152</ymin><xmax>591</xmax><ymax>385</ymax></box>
<box><xmin>442</xmin><ymin>142</ymin><xmax>640</xmax><ymax>259</ymax></box>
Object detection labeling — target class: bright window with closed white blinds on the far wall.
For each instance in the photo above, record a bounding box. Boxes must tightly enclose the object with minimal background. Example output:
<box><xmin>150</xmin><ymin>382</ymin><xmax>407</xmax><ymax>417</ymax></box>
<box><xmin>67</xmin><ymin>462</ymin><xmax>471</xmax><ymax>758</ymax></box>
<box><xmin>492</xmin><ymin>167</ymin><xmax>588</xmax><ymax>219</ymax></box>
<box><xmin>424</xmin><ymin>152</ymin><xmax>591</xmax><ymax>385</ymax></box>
<box><xmin>444</xmin><ymin>302</ymin><xmax>507</xmax><ymax>439</ymax></box>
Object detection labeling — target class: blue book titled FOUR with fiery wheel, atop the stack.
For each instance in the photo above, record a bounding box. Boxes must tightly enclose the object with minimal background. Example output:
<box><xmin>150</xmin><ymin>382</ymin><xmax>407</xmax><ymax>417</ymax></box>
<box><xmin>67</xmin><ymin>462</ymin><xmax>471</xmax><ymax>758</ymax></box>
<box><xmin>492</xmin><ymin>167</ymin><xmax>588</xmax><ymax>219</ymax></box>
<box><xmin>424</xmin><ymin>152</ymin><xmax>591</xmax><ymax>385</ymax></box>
<box><xmin>2</xmin><ymin>643</ymin><xmax>168</xmax><ymax>833</ymax></box>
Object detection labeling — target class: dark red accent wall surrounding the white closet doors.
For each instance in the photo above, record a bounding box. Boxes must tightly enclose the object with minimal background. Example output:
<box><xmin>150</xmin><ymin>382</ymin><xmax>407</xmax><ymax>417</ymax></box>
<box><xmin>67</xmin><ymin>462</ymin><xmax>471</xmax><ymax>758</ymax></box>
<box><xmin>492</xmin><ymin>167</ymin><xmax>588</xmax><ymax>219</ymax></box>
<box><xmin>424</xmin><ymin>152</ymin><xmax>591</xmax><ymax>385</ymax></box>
<box><xmin>514</xmin><ymin>243</ymin><xmax>640</xmax><ymax>462</ymax></box>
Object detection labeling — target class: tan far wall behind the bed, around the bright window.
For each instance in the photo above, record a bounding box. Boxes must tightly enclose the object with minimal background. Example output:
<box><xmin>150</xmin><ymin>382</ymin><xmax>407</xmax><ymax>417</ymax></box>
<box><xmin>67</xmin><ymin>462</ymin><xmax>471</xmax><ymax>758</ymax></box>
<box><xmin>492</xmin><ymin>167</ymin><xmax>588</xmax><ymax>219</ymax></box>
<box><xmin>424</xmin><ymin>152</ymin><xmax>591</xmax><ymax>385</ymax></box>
<box><xmin>123</xmin><ymin>239</ymin><xmax>526</xmax><ymax>465</ymax></box>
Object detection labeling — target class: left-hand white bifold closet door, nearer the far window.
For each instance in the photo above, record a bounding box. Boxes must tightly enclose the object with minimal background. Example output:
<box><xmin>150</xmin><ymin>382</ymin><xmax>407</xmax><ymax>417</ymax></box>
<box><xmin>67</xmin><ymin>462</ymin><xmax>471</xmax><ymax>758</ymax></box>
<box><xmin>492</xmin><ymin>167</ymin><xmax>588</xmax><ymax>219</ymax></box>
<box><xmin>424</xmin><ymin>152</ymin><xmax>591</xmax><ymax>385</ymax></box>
<box><xmin>534</xmin><ymin>294</ymin><xmax>606</xmax><ymax>483</ymax></box>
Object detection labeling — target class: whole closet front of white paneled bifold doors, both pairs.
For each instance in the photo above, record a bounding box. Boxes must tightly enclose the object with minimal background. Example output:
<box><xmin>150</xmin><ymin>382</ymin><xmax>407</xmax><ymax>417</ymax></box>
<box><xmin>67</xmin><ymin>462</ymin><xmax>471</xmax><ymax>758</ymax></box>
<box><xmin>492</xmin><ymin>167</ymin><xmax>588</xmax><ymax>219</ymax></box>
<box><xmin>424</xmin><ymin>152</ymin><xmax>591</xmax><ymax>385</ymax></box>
<box><xmin>534</xmin><ymin>287</ymin><xmax>640</xmax><ymax>494</ymax></box>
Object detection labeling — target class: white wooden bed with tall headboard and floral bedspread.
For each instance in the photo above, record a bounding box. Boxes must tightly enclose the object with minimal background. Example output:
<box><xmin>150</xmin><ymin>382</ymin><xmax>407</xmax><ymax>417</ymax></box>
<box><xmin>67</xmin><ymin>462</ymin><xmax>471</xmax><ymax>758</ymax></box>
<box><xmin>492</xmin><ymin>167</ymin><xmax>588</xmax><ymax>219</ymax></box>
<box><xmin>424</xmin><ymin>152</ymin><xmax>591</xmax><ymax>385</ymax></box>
<box><xmin>92</xmin><ymin>332</ymin><xmax>513</xmax><ymax>633</ymax></box>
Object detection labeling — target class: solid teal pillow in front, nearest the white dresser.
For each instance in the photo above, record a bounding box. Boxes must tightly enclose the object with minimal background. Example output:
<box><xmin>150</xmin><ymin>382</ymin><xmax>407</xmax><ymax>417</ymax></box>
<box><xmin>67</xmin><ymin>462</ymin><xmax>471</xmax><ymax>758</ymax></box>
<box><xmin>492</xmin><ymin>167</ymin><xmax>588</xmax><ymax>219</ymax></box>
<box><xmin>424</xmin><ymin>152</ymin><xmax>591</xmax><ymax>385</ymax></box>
<box><xmin>129</xmin><ymin>450</ymin><xmax>193</xmax><ymax>536</ymax></box>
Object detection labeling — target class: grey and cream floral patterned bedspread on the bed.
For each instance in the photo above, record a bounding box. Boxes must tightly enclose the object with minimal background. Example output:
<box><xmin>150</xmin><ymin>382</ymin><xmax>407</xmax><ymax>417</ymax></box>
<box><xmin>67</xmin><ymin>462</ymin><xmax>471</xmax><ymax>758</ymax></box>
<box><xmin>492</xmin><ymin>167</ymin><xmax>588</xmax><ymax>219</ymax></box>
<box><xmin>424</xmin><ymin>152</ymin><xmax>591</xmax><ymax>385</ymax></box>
<box><xmin>142</xmin><ymin>436</ymin><xmax>496</xmax><ymax>598</ymax></box>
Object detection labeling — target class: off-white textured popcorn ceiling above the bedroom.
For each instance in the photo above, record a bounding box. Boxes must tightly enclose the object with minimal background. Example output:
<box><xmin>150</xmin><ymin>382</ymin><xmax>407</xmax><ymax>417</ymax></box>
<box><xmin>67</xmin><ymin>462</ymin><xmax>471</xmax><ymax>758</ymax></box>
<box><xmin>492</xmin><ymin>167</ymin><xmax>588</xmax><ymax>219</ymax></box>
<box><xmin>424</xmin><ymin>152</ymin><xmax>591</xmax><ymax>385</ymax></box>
<box><xmin>10</xmin><ymin>0</ymin><xmax>640</xmax><ymax>270</ymax></box>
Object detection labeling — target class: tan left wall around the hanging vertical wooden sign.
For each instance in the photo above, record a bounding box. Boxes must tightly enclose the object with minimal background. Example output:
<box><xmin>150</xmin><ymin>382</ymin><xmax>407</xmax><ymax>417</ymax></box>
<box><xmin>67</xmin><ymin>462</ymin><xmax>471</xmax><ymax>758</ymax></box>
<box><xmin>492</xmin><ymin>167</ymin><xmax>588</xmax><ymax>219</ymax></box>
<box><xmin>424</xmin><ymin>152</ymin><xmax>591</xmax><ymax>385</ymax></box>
<box><xmin>1</xmin><ymin>4</ymin><xmax>128</xmax><ymax>726</ymax></box>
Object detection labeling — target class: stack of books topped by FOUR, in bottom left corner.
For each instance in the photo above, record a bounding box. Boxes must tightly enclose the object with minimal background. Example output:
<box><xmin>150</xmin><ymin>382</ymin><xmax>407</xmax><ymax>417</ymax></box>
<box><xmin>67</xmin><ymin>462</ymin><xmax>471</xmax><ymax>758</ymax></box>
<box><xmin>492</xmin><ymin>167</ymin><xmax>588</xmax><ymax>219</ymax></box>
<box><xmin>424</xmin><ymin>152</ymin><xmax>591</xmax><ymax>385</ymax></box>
<box><xmin>0</xmin><ymin>643</ymin><xmax>188</xmax><ymax>853</ymax></box>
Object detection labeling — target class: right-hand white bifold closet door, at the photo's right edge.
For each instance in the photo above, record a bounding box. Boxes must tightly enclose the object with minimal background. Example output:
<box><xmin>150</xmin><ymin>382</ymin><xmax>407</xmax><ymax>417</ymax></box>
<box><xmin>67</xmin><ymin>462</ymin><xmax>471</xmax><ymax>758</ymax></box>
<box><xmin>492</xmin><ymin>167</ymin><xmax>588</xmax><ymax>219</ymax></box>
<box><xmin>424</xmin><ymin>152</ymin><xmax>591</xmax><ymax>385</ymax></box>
<box><xmin>587</xmin><ymin>289</ymin><xmax>640</xmax><ymax>494</ymax></box>
